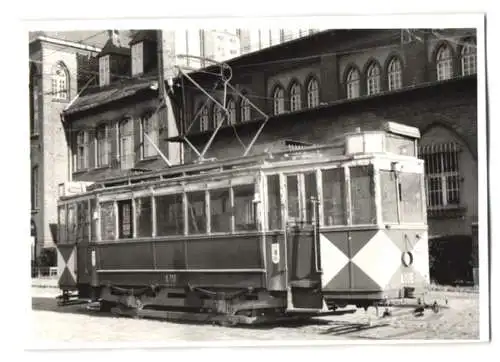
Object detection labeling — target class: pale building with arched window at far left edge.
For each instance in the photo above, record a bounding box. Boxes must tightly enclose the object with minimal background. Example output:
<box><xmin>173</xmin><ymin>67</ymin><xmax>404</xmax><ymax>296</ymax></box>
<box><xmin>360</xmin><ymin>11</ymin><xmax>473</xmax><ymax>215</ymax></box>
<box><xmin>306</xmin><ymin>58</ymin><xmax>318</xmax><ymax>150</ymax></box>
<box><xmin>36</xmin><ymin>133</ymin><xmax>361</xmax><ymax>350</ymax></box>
<box><xmin>29</xmin><ymin>33</ymin><xmax>100</xmax><ymax>257</ymax></box>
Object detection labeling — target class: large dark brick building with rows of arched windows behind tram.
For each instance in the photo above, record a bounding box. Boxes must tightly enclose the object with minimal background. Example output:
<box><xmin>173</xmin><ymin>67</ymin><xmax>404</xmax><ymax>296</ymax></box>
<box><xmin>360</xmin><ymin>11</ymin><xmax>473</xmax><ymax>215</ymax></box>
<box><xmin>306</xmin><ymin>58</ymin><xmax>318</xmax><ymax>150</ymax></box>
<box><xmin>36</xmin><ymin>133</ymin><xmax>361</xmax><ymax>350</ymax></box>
<box><xmin>170</xmin><ymin>29</ymin><xmax>478</xmax><ymax>282</ymax></box>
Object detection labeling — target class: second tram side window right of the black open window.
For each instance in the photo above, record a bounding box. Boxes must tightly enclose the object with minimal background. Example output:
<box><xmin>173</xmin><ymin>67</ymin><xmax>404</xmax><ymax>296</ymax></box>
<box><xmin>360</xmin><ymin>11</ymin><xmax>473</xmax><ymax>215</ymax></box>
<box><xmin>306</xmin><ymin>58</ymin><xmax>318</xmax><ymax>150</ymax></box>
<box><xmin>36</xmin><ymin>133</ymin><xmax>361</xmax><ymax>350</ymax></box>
<box><xmin>156</xmin><ymin>194</ymin><xmax>184</xmax><ymax>236</ymax></box>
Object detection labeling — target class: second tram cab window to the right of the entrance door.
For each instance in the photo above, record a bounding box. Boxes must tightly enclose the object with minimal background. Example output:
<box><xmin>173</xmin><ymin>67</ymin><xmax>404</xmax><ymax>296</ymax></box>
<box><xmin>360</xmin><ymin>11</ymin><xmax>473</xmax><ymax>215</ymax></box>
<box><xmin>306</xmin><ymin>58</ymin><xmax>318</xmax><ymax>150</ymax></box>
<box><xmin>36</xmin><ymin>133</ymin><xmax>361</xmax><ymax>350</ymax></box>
<box><xmin>350</xmin><ymin>166</ymin><xmax>376</xmax><ymax>225</ymax></box>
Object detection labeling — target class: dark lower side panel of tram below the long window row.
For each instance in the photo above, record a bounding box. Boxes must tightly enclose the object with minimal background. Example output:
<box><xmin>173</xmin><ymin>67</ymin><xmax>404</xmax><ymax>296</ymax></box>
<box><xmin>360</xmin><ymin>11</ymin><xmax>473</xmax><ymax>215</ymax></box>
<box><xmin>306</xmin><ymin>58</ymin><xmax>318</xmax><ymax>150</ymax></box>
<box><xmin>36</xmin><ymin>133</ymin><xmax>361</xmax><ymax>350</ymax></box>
<box><xmin>93</xmin><ymin>235</ymin><xmax>266</xmax><ymax>288</ymax></box>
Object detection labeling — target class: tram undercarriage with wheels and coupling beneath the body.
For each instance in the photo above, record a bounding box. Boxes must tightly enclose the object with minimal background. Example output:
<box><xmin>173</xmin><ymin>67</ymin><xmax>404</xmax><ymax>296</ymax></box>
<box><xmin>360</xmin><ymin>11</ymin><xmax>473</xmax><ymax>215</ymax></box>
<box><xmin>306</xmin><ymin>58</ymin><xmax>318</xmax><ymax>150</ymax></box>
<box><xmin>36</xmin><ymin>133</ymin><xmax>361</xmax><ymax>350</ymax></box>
<box><xmin>58</xmin><ymin>286</ymin><xmax>448</xmax><ymax>326</ymax></box>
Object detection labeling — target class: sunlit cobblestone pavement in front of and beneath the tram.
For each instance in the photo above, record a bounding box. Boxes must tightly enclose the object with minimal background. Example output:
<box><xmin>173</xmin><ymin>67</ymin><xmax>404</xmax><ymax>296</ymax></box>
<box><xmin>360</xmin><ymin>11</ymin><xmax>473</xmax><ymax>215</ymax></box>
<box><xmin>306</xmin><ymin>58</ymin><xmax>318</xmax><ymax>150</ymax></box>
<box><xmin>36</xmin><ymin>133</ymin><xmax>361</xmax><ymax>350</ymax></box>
<box><xmin>28</xmin><ymin>288</ymin><xmax>479</xmax><ymax>343</ymax></box>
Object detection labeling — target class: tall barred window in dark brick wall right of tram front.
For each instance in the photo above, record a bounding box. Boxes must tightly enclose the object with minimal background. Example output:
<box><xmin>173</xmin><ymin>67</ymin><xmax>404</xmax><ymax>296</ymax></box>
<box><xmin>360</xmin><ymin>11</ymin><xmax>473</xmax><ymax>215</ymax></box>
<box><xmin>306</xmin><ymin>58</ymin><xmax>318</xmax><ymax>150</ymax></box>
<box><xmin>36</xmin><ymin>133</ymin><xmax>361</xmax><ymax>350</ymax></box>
<box><xmin>419</xmin><ymin>143</ymin><xmax>461</xmax><ymax>211</ymax></box>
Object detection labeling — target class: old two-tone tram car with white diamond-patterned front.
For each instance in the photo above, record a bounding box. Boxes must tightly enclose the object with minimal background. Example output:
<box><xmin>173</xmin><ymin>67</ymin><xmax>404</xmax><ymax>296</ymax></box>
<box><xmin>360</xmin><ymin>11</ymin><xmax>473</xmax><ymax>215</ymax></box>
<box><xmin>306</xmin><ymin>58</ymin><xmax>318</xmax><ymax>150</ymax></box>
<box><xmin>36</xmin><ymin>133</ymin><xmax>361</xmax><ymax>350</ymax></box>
<box><xmin>53</xmin><ymin>122</ymin><xmax>430</xmax><ymax>323</ymax></box>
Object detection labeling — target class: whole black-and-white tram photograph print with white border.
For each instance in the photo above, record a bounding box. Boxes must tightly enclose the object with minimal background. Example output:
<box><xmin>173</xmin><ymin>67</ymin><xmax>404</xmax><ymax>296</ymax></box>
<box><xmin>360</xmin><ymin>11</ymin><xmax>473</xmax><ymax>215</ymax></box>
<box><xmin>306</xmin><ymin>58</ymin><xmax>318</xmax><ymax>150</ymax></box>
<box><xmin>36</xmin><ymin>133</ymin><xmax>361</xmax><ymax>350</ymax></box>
<box><xmin>9</xmin><ymin>4</ymin><xmax>494</xmax><ymax>356</ymax></box>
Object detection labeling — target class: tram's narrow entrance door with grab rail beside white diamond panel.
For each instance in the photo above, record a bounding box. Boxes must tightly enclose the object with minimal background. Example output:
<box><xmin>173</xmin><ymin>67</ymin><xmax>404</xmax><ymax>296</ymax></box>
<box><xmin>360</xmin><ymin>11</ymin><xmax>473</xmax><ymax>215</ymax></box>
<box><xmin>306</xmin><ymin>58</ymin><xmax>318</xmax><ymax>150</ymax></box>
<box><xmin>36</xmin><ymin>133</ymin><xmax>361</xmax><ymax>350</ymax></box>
<box><xmin>284</xmin><ymin>172</ymin><xmax>322</xmax><ymax>309</ymax></box>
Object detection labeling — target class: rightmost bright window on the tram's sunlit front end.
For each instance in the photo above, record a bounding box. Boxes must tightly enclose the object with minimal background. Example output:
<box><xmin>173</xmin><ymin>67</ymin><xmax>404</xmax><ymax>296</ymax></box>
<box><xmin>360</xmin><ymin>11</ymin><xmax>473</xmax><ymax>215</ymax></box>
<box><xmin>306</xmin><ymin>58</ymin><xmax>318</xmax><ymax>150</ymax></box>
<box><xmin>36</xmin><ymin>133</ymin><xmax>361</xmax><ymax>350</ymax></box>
<box><xmin>399</xmin><ymin>172</ymin><xmax>423</xmax><ymax>223</ymax></box>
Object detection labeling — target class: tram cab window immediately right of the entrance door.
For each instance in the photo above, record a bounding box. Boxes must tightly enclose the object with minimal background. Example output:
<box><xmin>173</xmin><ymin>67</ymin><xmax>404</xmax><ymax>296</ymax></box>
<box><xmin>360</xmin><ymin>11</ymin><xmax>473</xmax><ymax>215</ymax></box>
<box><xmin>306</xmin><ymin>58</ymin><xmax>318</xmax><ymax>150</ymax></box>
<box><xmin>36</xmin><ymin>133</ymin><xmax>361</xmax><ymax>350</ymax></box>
<box><xmin>323</xmin><ymin>168</ymin><xmax>346</xmax><ymax>226</ymax></box>
